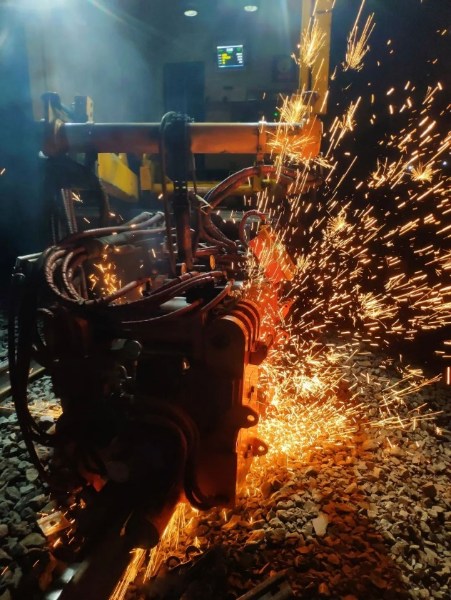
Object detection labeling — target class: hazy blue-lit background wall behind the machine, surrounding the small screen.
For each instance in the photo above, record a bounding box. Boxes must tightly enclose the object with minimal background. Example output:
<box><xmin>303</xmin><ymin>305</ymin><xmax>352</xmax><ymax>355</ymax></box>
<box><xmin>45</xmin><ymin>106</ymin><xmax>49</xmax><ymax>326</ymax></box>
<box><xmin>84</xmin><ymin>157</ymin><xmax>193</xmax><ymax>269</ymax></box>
<box><xmin>7</xmin><ymin>0</ymin><xmax>301</xmax><ymax>122</ymax></box>
